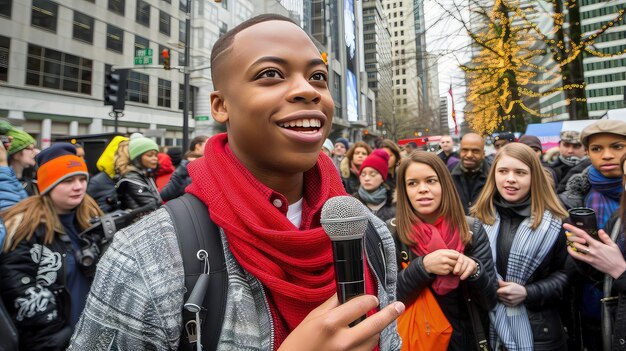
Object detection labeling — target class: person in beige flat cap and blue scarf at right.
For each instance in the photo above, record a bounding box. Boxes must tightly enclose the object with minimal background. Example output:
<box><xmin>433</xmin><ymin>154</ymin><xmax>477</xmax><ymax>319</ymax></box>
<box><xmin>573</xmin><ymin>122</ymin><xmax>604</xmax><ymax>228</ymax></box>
<box><xmin>559</xmin><ymin>120</ymin><xmax>626</xmax><ymax>350</ymax></box>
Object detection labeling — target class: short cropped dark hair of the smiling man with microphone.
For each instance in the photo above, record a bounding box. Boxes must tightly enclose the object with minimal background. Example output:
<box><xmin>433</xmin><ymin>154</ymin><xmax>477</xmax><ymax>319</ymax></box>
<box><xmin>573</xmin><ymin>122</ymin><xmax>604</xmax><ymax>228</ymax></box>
<box><xmin>211</xmin><ymin>13</ymin><xmax>299</xmax><ymax>90</ymax></box>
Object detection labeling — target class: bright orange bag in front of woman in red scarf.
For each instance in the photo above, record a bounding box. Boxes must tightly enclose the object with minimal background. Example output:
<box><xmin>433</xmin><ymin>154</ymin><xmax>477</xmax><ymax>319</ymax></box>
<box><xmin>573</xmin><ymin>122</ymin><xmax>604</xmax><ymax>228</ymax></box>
<box><xmin>398</xmin><ymin>288</ymin><xmax>452</xmax><ymax>351</ymax></box>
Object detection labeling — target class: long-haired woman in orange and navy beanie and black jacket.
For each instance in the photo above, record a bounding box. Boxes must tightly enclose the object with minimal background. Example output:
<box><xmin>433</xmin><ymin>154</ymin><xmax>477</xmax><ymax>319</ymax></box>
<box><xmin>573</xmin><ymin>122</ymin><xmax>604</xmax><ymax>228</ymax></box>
<box><xmin>0</xmin><ymin>143</ymin><xmax>102</xmax><ymax>350</ymax></box>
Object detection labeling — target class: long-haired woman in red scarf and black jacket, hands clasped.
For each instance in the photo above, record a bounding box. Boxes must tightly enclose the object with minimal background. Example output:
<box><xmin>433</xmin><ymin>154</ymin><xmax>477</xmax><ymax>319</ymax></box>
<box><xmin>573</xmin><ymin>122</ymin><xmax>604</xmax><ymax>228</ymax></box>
<box><xmin>390</xmin><ymin>151</ymin><xmax>497</xmax><ymax>350</ymax></box>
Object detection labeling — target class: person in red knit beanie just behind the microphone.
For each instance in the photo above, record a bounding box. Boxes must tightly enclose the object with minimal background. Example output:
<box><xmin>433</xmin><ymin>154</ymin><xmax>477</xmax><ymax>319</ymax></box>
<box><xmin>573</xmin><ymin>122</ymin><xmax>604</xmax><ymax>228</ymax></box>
<box><xmin>352</xmin><ymin>149</ymin><xmax>396</xmax><ymax>222</ymax></box>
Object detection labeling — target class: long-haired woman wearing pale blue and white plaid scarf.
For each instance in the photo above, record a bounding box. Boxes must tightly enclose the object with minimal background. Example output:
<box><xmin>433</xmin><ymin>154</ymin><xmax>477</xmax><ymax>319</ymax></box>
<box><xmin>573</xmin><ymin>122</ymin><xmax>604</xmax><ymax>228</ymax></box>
<box><xmin>471</xmin><ymin>143</ymin><xmax>568</xmax><ymax>351</ymax></box>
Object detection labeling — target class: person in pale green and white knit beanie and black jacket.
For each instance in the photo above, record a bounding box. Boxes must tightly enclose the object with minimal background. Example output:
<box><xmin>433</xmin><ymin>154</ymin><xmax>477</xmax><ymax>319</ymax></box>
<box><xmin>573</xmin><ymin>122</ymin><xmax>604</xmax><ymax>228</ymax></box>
<box><xmin>115</xmin><ymin>135</ymin><xmax>163</xmax><ymax>212</ymax></box>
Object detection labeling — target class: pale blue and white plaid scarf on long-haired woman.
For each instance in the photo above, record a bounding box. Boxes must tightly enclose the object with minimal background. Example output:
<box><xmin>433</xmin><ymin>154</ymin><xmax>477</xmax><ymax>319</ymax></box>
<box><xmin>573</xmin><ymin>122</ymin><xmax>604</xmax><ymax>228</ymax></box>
<box><xmin>483</xmin><ymin>211</ymin><xmax>561</xmax><ymax>351</ymax></box>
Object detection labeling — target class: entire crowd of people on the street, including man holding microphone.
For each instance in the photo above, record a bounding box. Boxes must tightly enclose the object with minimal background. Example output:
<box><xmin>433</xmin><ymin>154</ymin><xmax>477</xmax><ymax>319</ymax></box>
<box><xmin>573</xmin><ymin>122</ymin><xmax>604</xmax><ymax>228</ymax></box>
<box><xmin>0</xmin><ymin>15</ymin><xmax>626</xmax><ymax>351</ymax></box>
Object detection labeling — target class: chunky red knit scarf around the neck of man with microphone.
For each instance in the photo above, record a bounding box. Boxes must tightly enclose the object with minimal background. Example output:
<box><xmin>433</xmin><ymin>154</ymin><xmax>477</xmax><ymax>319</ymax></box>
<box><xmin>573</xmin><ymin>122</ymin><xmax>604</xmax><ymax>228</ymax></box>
<box><xmin>186</xmin><ymin>134</ymin><xmax>346</xmax><ymax>336</ymax></box>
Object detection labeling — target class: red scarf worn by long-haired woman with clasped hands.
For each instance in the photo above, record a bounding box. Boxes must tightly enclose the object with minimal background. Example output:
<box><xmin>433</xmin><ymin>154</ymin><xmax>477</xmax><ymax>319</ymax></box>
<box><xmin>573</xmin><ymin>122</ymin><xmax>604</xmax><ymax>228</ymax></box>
<box><xmin>411</xmin><ymin>217</ymin><xmax>465</xmax><ymax>295</ymax></box>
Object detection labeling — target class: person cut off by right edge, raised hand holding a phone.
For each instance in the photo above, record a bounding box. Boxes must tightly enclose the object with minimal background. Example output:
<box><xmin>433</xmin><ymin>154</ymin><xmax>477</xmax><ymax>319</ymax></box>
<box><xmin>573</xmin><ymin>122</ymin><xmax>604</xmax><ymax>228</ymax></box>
<box><xmin>563</xmin><ymin>155</ymin><xmax>626</xmax><ymax>350</ymax></box>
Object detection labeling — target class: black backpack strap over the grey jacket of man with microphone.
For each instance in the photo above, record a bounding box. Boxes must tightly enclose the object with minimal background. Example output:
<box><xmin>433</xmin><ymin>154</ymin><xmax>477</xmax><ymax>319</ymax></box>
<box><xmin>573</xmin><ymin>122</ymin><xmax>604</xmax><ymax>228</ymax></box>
<box><xmin>164</xmin><ymin>194</ymin><xmax>228</xmax><ymax>351</ymax></box>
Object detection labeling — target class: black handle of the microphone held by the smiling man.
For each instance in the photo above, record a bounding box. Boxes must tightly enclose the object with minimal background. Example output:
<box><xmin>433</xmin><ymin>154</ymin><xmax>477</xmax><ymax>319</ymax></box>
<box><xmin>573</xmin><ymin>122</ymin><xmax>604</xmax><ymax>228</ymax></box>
<box><xmin>332</xmin><ymin>238</ymin><xmax>366</xmax><ymax>326</ymax></box>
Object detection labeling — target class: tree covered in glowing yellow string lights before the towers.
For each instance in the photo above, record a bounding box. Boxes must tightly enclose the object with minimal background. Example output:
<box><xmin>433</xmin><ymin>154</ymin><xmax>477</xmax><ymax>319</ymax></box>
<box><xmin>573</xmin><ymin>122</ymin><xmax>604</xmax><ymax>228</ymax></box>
<box><xmin>461</xmin><ymin>0</ymin><xmax>573</xmax><ymax>135</ymax></box>
